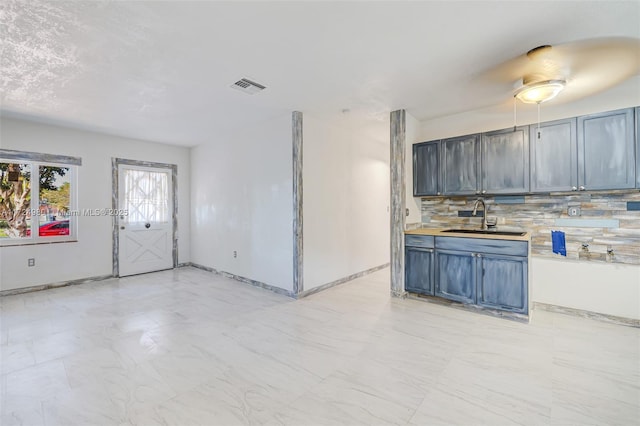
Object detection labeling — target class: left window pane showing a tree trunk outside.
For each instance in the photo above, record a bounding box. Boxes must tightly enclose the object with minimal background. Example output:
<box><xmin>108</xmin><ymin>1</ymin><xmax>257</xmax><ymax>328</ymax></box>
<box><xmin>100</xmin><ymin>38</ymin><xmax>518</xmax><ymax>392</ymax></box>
<box><xmin>0</xmin><ymin>162</ymin><xmax>31</xmax><ymax>239</ymax></box>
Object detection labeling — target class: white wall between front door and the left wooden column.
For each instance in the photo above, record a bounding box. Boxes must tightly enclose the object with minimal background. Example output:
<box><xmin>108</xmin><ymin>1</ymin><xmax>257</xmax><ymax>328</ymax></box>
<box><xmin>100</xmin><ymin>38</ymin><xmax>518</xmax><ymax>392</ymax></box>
<box><xmin>191</xmin><ymin>113</ymin><xmax>293</xmax><ymax>290</ymax></box>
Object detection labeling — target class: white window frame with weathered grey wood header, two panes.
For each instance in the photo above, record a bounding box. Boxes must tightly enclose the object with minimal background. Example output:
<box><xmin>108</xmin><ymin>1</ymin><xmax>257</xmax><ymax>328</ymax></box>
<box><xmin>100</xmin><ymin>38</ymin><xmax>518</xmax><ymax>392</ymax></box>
<box><xmin>0</xmin><ymin>149</ymin><xmax>82</xmax><ymax>247</ymax></box>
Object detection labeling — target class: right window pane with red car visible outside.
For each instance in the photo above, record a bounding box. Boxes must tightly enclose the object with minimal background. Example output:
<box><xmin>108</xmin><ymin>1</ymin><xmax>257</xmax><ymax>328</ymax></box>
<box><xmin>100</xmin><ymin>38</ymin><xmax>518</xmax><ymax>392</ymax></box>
<box><xmin>37</xmin><ymin>166</ymin><xmax>71</xmax><ymax>237</ymax></box>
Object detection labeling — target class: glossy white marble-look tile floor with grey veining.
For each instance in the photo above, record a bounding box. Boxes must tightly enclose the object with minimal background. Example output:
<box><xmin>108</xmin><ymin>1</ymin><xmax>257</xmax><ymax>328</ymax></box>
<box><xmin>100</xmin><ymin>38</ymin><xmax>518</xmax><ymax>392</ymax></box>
<box><xmin>0</xmin><ymin>268</ymin><xmax>640</xmax><ymax>426</ymax></box>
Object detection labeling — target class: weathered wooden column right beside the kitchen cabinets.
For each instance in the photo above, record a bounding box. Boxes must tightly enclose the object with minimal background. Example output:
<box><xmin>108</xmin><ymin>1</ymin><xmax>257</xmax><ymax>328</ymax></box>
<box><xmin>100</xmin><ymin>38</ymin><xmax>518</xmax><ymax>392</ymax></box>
<box><xmin>390</xmin><ymin>109</ymin><xmax>407</xmax><ymax>297</ymax></box>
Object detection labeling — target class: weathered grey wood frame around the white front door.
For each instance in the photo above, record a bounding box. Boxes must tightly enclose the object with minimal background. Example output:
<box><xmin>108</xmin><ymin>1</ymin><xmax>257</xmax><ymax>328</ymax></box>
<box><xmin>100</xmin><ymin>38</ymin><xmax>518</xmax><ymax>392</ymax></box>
<box><xmin>111</xmin><ymin>157</ymin><xmax>178</xmax><ymax>277</ymax></box>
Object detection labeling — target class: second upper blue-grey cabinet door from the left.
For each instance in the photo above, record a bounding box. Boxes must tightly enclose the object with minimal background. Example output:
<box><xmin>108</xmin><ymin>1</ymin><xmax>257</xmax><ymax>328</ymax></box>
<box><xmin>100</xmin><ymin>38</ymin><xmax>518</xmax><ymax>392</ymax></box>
<box><xmin>440</xmin><ymin>135</ymin><xmax>480</xmax><ymax>195</ymax></box>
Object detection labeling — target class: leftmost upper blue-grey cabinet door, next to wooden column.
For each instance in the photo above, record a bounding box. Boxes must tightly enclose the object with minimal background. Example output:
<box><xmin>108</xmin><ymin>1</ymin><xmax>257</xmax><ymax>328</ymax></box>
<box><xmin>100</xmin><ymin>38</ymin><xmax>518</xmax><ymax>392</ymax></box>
<box><xmin>413</xmin><ymin>141</ymin><xmax>440</xmax><ymax>197</ymax></box>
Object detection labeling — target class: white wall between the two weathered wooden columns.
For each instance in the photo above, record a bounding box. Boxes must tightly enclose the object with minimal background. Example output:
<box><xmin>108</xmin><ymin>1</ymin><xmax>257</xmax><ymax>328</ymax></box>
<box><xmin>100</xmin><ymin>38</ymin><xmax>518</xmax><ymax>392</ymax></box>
<box><xmin>303</xmin><ymin>113</ymin><xmax>390</xmax><ymax>290</ymax></box>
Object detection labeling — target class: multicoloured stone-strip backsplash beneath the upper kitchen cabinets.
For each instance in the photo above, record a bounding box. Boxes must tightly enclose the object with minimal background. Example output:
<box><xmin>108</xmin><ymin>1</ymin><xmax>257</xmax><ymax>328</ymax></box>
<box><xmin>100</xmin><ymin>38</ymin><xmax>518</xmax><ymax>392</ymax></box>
<box><xmin>418</xmin><ymin>191</ymin><xmax>640</xmax><ymax>264</ymax></box>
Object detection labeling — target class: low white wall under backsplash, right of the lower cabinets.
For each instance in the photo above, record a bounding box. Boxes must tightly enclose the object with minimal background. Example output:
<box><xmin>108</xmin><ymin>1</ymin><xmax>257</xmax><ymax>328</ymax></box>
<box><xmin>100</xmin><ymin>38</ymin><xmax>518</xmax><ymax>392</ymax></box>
<box><xmin>530</xmin><ymin>257</ymin><xmax>640</xmax><ymax>319</ymax></box>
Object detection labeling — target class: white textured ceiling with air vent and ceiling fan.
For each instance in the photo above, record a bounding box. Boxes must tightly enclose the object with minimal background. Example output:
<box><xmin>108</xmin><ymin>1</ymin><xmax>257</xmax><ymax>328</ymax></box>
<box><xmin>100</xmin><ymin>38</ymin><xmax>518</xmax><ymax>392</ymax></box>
<box><xmin>0</xmin><ymin>0</ymin><xmax>640</xmax><ymax>146</ymax></box>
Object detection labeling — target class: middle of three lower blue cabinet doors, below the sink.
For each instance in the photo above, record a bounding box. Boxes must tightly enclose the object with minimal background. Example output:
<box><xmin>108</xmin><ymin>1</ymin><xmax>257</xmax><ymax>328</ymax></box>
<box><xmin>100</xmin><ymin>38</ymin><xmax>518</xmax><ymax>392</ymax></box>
<box><xmin>436</xmin><ymin>250</ymin><xmax>476</xmax><ymax>303</ymax></box>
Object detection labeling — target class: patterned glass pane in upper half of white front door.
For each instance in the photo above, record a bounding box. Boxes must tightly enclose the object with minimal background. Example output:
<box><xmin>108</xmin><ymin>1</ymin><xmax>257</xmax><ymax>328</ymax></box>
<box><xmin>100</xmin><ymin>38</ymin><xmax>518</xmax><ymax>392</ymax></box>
<box><xmin>123</xmin><ymin>169</ymin><xmax>170</xmax><ymax>223</ymax></box>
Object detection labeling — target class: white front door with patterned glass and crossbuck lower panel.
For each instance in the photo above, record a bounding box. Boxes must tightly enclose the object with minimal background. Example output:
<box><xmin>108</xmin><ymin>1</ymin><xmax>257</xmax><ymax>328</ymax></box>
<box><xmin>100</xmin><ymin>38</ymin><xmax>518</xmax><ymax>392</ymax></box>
<box><xmin>118</xmin><ymin>164</ymin><xmax>173</xmax><ymax>277</ymax></box>
